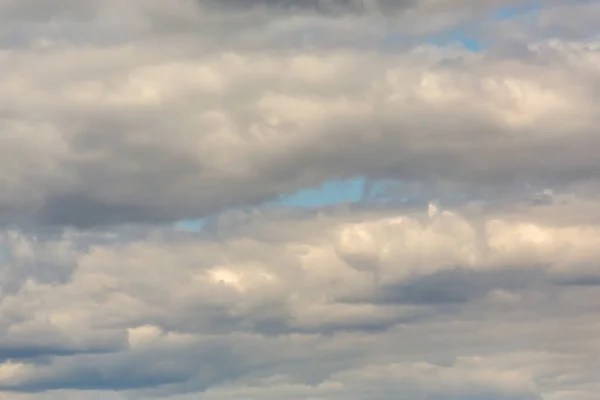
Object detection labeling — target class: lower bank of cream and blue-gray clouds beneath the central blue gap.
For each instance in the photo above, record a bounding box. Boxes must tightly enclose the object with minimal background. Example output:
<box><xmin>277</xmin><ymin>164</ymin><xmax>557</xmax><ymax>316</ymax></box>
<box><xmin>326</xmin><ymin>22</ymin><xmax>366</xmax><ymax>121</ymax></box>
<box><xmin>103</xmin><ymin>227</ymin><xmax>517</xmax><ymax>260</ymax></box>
<box><xmin>0</xmin><ymin>204</ymin><xmax>600</xmax><ymax>399</ymax></box>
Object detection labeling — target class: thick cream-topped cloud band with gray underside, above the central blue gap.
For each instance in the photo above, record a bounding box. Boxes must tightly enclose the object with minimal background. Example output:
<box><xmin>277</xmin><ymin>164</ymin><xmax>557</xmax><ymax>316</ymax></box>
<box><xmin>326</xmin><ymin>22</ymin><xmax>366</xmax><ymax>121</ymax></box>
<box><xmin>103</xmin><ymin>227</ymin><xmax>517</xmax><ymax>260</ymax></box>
<box><xmin>0</xmin><ymin>38</ymin><xmax>598</xmax><ymax>226</ymax></box>
